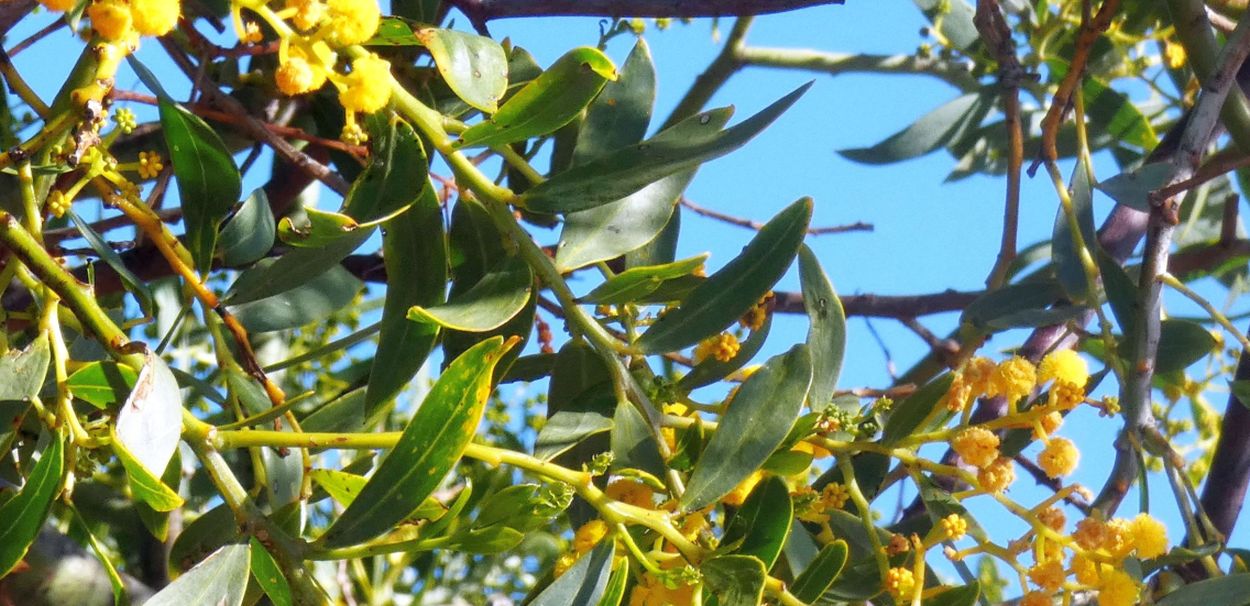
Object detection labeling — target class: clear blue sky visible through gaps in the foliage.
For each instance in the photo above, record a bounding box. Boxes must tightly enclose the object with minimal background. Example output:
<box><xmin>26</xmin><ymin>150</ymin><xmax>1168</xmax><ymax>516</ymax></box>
<box><xmin>10</xmin><ymin>1</ymin><xmax>1250</xmax><ymax>589</ymax></box>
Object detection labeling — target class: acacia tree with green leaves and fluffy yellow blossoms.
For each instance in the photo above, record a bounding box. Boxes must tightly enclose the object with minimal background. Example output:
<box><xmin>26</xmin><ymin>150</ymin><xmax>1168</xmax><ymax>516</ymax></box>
<box><xmin>0</xmin><ymin>0</ymin><xmax>1250</xmax><ymax>606</ymax></box>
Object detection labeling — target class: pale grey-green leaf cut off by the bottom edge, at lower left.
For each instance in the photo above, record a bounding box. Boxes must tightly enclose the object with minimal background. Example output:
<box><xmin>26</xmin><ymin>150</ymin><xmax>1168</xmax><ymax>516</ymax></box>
<box><xmin>144</xmin><ymin>544</ymin><xmax>251</xmax><ymax>606</ymax></box>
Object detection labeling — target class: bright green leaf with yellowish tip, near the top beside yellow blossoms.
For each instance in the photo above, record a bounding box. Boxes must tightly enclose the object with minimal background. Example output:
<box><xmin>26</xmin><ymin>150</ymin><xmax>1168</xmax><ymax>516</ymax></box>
<box><xmin>454</xmin><ymin>46</ymin><xmax>616</xmax><ymax>147</ymax></box>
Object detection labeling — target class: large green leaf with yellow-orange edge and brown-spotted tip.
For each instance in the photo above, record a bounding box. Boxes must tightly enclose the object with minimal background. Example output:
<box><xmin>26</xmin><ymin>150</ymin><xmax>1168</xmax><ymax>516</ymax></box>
<box><xmin>319</xmin><ymin>337</ymin><xmax>513</xmax><ymax>549</ymax></box>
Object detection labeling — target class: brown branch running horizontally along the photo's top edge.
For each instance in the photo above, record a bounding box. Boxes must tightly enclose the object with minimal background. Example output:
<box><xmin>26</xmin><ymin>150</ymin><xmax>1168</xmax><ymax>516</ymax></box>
<box><xmin>446</xmin><ymin>0</ymin><xmax>844</xmax><ymax>32</ymax></box>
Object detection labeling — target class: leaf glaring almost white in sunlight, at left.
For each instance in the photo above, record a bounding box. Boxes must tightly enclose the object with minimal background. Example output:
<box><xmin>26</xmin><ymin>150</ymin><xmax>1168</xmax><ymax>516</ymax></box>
<box><xmin>116</xmin><ymin>352</ymin><xmax>183</xmax><ymax>477</ymax></box>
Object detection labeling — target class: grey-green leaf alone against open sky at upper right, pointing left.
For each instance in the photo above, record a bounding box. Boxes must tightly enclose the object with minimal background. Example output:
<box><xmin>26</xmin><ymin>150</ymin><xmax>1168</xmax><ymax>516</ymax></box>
<box><xmin>838</xmin><ymin>91</ymin><xmax>994</xmax><ymax>164</ymax></box>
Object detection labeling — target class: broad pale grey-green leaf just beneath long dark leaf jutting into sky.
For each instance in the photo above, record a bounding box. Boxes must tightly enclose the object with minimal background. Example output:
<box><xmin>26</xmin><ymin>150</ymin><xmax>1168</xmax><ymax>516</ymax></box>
<box><xmin>555</xmin><ymin>171</ymin><xmax>695</xmax><ymax>271</ymax></box>
